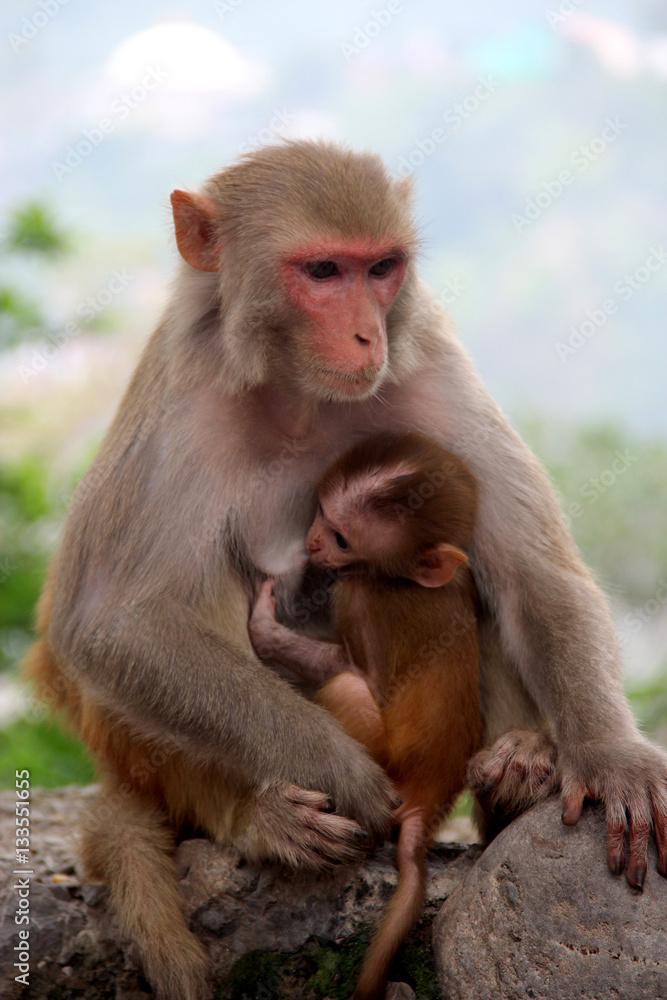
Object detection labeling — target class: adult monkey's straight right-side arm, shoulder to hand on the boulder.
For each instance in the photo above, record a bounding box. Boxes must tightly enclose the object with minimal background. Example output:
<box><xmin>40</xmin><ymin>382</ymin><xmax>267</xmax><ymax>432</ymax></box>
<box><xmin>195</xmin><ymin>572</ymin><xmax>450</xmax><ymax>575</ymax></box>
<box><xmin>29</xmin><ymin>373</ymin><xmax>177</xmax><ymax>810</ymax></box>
<box><xmin>416</xmin><ymin>302</ymin><xmax>667</xmax><ymax>886</ymax></box>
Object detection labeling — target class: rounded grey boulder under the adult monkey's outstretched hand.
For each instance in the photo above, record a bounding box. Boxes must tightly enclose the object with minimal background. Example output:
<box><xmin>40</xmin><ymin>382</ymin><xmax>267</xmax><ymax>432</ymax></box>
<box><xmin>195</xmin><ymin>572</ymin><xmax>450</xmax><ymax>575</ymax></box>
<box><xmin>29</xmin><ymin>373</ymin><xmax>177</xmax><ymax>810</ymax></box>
<box><xmin>433</xmin><ymin>799</ymin><xmax>667</xmax><ymax>1000</ymax></box>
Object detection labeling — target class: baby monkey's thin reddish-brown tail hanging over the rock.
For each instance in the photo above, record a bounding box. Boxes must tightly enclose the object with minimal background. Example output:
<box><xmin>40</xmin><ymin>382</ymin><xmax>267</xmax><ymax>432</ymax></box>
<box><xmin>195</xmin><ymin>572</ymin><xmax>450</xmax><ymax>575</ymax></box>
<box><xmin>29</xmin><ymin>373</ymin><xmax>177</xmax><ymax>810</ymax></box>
<box><xmin>352</xmin><ymin>802</ymin><xmax>430</xmax><ymax>1000</ymax></box>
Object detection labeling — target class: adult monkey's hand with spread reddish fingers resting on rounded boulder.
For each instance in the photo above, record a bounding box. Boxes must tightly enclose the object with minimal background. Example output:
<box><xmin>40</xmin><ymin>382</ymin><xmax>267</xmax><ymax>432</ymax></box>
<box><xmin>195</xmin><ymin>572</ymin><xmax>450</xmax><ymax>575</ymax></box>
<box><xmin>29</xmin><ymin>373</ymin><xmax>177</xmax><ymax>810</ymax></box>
<box><xmin>559</xmin><ymin>736</ymin><xmax>667</xmax><ymax>889</ymax></box>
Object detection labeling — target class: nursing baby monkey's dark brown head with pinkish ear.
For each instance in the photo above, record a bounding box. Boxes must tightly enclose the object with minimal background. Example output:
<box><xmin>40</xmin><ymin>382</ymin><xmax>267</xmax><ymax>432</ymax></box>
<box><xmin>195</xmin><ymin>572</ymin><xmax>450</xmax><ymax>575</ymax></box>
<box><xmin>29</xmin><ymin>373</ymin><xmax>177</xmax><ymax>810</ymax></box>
<box><xmin>306</xmin><ymin>434</ymin><xmax>477</xmax><ymax>587</ymax></box>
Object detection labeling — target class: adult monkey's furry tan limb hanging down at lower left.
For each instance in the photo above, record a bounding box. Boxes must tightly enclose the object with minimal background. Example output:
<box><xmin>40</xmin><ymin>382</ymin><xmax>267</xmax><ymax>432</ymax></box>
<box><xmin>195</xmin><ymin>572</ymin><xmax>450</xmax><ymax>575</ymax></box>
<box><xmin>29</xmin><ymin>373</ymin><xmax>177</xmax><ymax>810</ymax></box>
<box><xmin>81</xmin><ymin>781</ymin><xmax>209</xmax><ymax>1000</ymax></box>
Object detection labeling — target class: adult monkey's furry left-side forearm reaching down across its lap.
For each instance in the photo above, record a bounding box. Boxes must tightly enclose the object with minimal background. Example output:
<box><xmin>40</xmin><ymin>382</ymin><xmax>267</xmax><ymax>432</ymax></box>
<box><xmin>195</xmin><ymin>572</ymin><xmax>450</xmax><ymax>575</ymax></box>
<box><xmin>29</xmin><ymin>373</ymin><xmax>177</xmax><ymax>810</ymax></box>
<box><xmin>48</xmin><ymin>564</ymin><xmax>394</xmax><ymax>852</ymax></box>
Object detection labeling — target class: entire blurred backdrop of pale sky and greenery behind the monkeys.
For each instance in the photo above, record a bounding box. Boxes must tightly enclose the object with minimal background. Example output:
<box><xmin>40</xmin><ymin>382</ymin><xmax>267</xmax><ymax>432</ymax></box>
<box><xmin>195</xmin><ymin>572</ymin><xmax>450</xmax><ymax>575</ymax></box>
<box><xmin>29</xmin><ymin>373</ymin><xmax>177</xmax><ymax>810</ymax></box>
<box><xmin>0</xmin><ymin>0</ymin><xmax>667</xmax><ymax>785</ymax></box>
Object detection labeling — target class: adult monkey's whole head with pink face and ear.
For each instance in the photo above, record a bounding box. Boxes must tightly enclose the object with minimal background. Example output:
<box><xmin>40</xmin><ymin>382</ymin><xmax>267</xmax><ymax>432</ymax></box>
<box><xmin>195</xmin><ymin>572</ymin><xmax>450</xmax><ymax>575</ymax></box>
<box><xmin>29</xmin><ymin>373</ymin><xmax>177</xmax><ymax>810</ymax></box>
<box><xmin>171</xmin><ymin>142</ymin><xmax>416</xmax><ymax>400</ymax></box>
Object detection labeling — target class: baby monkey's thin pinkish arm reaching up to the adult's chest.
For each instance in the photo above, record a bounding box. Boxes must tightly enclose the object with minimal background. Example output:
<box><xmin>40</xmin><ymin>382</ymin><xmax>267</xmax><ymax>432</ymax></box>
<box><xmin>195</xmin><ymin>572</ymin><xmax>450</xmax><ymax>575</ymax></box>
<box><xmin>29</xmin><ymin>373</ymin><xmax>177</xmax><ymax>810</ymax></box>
<box><xmin>248</xmin><ymin>579</ymin><xmax>356</xmax><ymax>684</ymax></box>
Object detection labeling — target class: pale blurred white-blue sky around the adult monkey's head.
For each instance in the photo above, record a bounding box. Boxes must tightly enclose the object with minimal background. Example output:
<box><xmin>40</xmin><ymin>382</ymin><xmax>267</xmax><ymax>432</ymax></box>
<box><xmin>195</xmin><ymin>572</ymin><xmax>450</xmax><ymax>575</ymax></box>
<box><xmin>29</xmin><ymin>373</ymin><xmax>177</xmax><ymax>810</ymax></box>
<box><xmin>0</xmin><ymin>0</ymin><xmax>667</xmax><ymax>434</ymax></box>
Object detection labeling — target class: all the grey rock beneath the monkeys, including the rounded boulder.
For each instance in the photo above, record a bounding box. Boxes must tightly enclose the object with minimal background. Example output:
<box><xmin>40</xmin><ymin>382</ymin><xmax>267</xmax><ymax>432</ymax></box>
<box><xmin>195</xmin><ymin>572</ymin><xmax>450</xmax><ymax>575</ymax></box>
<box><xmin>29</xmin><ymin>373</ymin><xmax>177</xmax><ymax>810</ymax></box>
<box><xmin>5</xmin><ymin>787</ymin><xmax>667</xmax><ymax>1000</ymax></box>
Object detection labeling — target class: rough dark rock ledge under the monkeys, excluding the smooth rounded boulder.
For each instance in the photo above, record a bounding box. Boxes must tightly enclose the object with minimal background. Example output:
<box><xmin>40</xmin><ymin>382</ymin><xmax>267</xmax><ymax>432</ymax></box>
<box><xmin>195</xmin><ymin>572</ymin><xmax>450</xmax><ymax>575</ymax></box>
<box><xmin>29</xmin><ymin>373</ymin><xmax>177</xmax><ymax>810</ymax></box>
<box><xmin>0</xmin><ymin>786</ymin><xmax>481</xmax><ymax>1000</ymax></box>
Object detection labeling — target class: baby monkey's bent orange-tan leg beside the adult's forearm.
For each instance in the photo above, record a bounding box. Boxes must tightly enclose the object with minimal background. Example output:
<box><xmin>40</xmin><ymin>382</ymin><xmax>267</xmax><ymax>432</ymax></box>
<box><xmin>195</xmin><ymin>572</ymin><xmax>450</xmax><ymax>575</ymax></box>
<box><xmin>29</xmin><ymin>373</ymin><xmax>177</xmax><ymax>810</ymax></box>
<box><xmin>316</xmin><ymin>671</ymin><xmax>387</xmax><ymax>766</ymax></box>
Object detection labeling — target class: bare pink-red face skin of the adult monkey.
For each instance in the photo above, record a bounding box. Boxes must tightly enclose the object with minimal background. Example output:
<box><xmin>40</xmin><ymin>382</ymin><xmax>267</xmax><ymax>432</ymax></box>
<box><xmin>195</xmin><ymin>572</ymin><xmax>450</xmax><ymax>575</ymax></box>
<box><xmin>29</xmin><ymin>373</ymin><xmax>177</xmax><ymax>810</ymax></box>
<box><xmin>282</xmin><ymin>237</ymin><xmax>408</xmax><ymax>399</ymax></box>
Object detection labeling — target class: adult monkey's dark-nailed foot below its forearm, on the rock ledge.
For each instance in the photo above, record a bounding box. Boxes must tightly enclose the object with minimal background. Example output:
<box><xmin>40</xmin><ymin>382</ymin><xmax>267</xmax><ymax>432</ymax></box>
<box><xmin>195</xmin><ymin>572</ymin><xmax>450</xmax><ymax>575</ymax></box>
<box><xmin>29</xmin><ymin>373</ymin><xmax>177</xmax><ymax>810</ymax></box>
<box><xmin>237</xmin><ymin>783</ymin><xmax>366</xmax><ymax>869</ymax></box>
